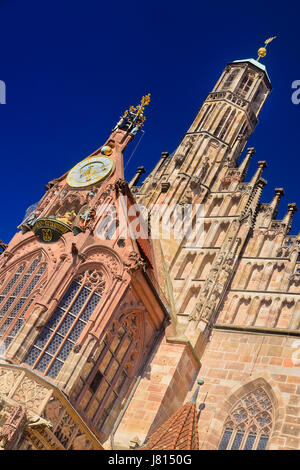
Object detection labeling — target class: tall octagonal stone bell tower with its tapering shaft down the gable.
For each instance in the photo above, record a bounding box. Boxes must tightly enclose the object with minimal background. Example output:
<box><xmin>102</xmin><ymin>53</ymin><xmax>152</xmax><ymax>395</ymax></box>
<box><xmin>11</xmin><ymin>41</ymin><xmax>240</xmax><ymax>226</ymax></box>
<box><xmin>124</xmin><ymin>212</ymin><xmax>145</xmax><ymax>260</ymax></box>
<box><xmin>131</xmin><ymin>42</ymin><xmax>272</xmax><ymax>355</ymax></box>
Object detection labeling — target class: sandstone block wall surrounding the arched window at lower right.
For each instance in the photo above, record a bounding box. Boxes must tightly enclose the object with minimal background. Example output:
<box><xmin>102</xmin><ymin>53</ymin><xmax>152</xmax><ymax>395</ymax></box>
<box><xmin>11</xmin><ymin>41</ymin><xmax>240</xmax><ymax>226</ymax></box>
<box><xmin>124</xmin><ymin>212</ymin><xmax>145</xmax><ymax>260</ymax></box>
<box><xmin>198</xmin><ymin>330</ymin><xmax>300</xmax><ymax>450</ymax></box>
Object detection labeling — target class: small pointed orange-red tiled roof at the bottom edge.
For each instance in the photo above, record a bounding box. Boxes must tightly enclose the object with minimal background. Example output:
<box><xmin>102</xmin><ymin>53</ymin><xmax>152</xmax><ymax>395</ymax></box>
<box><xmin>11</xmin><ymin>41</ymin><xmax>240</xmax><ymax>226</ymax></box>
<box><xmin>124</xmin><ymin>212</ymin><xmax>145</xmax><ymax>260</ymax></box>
<box><xmin>140</xmin><ymin>402</ymin><xmax>199</xmax><ymax>450</ymax></box>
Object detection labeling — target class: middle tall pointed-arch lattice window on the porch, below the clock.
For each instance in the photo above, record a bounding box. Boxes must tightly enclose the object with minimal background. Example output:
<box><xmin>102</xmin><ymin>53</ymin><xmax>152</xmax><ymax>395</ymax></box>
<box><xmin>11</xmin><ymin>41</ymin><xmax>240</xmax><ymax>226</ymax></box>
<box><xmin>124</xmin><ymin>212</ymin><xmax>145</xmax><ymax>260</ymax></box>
<box><xmin>24</xmin><ymin>270</ymin><xmax>105</xmax><ymax>379</ymax></box>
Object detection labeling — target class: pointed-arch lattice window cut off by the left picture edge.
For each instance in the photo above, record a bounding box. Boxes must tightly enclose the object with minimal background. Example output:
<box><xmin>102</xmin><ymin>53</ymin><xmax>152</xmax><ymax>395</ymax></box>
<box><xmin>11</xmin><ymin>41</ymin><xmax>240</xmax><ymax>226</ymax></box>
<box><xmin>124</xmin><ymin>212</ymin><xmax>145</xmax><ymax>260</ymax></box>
<box><xmin>0</xmin><ymin>256</ymin><xmax>46</xmax><ymax>347</ymax></box>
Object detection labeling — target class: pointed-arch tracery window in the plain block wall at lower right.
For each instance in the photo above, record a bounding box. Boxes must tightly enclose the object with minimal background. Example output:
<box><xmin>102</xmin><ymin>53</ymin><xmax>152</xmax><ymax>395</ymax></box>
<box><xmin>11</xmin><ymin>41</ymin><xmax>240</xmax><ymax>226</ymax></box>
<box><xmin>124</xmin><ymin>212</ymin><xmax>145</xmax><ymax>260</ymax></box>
<box><xmin>219</xmin><ymin>387</ymin><xmax>273</xmax><ymax>450</ymax></box>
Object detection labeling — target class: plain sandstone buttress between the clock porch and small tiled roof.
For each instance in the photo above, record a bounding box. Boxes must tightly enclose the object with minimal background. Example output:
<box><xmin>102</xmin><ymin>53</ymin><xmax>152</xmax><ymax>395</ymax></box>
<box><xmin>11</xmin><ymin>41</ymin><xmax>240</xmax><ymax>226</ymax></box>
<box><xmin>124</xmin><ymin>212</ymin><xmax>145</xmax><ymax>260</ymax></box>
<box><xmin>115</xmin><ymin>338</ymin><xmax>199</xmax><ymax>448</ymax></box>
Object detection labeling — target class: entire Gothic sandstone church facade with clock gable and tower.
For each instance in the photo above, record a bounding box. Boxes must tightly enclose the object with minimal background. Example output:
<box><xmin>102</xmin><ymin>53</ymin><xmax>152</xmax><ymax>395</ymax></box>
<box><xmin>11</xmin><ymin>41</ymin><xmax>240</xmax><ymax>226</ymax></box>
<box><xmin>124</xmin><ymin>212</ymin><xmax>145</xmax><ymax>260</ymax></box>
<box><xmin>0</xmin><ymin>48</ymin><xmax>300</xmax><ymax>450</ymax></box>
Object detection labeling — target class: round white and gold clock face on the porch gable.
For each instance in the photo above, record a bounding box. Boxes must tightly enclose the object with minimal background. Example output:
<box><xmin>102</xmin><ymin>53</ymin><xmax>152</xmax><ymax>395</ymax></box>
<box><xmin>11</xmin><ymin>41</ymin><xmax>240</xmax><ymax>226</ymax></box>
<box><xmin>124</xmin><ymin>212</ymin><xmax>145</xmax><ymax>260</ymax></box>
<box><xmin>67</xmin><ymin>156</ymin><xmax>114</xmax><ymax>188</ymax></box>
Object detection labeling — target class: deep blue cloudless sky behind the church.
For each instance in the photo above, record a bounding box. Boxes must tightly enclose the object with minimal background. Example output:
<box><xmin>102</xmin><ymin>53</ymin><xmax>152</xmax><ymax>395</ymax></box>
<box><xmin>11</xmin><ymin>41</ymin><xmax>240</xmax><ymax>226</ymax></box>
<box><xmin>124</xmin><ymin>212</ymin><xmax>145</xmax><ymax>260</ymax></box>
<box><xmin>0</xmin><ymin>0</ymin><xmax>300</xmax><ymax>242</ymax></box>
